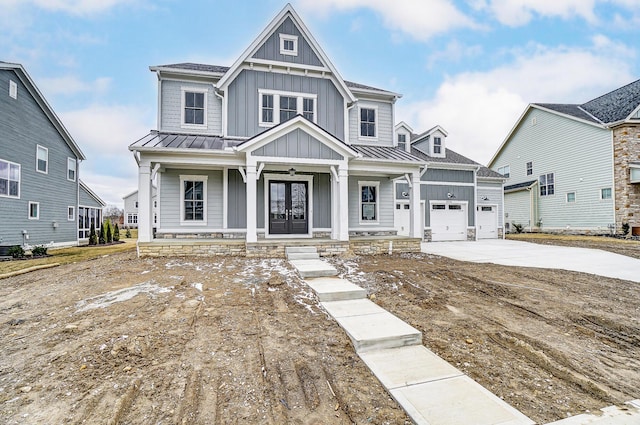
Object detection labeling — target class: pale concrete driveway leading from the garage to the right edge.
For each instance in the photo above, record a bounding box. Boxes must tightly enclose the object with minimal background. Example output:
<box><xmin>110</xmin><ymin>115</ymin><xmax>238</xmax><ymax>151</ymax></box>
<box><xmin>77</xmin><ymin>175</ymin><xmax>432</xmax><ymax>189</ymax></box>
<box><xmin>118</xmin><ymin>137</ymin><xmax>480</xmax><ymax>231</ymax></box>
<box><xmin>422</xmin><ymin>239</ymin><xmax>640</xmax><ymax>283</ymax></box>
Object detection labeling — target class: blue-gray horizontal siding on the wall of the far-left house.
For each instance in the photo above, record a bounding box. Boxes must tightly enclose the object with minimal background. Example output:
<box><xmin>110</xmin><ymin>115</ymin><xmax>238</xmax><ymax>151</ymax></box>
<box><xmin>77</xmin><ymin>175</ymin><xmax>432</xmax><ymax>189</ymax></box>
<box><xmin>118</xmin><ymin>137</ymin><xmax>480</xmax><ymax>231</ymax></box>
<box><xmin>0</xmin><ymin>70</ymin><xmax>79</xmax><ymax>245</ymax></box>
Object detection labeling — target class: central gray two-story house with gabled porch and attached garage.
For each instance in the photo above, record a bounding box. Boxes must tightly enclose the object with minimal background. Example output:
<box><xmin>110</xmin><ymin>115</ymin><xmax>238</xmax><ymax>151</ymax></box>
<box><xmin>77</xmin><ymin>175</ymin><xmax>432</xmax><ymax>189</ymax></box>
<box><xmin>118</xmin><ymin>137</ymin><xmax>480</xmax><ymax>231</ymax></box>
<box><xmin>129</xmin><ymin>5</ymin><xmax>502</xmax><ymax>255</ymax></box>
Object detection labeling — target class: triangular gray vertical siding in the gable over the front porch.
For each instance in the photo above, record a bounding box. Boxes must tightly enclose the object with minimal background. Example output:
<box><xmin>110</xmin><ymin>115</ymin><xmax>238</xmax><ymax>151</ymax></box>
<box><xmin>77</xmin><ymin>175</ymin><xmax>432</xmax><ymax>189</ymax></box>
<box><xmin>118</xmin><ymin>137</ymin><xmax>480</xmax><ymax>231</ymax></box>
<box><xmin>252</xmin><ymin>129</ymin><xmax>344</xmax><ymax>160</ymax></box>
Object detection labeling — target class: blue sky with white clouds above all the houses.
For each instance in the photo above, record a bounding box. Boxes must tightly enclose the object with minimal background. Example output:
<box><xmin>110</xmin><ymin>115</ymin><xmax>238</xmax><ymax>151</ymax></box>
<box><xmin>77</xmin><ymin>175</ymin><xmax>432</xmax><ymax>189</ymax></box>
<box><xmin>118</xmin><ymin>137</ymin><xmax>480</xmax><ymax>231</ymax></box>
<box><xmin>0</xmin><ymin>0</ymin><xmax>640</xmax><ymax>208</ymax></box>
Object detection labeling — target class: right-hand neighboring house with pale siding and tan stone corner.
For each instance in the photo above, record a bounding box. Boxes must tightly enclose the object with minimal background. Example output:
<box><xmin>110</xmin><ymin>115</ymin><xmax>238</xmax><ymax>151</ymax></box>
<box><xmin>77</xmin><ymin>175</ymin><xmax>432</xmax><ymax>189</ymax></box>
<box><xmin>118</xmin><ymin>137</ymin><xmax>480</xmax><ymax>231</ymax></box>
<box><xmin>489</xmin><ymin>80</ymin><xmax>640</xmax><ymax>235</ymax></box>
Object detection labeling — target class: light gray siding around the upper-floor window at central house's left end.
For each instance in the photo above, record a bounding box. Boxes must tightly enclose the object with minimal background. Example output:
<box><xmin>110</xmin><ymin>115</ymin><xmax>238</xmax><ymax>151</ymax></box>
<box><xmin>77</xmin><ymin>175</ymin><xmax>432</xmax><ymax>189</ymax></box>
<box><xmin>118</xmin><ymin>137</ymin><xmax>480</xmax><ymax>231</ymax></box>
<box><xmin>158</xmin><ymin>80</ymin><xmax>222</xmax><ymax>135</ymax></box>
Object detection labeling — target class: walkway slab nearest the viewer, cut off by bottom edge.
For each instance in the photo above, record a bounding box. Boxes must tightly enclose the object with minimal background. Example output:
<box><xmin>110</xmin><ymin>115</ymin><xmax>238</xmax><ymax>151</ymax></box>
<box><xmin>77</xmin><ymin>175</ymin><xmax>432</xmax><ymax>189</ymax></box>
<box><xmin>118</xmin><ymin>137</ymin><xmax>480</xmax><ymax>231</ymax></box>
<box><xmin>390</xmin><ymin>376</ymin><xmax>535</xmax><ymax>425</ymax></box>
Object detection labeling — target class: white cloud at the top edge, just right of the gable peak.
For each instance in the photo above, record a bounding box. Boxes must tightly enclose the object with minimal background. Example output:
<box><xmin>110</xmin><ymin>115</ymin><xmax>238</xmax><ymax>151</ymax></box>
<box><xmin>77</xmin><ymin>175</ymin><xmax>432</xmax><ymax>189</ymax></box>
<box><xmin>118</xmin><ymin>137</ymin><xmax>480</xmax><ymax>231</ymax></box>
<box><xmin>298</xmin><ymin>0</ymin><xmax>478</xmax><ymax>41</ymax></box>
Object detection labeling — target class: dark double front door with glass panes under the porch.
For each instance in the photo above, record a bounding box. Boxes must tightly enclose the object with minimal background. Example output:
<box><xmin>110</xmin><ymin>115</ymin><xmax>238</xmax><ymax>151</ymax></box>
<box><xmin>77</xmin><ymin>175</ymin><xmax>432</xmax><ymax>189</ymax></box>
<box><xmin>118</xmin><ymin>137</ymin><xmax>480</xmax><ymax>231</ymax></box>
<box><xmin>269</xmin><ymin>181</ymin><xmax>309</xmax><ymax>235</ymax></box>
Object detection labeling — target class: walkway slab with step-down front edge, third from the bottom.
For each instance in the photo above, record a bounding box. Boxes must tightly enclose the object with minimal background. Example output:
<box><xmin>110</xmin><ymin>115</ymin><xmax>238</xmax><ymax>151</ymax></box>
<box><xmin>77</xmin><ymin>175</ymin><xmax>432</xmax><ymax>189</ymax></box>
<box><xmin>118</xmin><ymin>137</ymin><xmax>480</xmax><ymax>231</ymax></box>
<box><xmin>336</xmin><ymin>308</ymin><xmax>422</xmax><ymax>353</ymax></box>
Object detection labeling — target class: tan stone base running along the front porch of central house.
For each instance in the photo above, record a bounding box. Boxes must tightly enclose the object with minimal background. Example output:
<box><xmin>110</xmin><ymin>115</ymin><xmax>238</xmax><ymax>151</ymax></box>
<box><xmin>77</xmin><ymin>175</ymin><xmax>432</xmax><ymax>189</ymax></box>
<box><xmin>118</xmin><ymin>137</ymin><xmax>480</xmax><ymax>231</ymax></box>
<box><xmin>138</xmin><ymin>236</ymin><xmax>421</xmax><ymax>258</ymax></box>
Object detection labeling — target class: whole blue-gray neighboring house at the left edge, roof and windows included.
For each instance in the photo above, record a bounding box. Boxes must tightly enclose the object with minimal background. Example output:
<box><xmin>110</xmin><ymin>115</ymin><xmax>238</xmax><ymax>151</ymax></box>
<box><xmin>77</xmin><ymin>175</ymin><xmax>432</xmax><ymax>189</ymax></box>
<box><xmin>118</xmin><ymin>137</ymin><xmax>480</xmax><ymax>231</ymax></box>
<box><xmin>0</xmin><ymin>62</ymin><xmax>104</xmax><ymax>247</ymax></box>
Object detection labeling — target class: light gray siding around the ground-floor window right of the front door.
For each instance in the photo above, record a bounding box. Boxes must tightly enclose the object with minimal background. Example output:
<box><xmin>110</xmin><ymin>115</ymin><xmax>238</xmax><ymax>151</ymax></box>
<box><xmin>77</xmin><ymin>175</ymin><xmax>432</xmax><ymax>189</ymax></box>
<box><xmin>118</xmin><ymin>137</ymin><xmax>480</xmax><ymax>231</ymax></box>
<box><xmin>349</xmin><ymin>176</ymin><xmax>395</xmax><ymax>230</ymax></box>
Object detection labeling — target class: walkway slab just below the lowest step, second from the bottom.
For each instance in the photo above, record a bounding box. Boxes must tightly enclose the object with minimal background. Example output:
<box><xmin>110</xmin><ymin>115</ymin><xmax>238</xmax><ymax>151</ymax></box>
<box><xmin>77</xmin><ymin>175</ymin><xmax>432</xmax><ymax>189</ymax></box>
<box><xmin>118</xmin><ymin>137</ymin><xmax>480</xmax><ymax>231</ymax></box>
<box><xmin>360</xmin><ymin>345</ymin><xmax>464</xmax><ymax>390</ymax></box>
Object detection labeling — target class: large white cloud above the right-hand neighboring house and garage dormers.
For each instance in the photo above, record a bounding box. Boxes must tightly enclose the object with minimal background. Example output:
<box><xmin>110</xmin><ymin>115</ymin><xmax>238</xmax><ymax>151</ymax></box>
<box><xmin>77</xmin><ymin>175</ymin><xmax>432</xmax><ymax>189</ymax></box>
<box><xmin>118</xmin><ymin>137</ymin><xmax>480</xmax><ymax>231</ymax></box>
<box><xmin>396</xmin><ymin>37</ymin><xmax>635</xmax><ymax>164</ymax></box>
